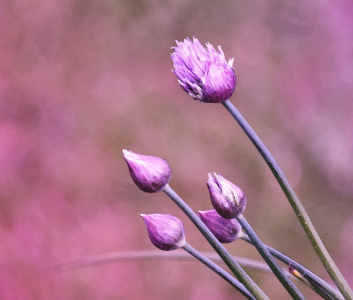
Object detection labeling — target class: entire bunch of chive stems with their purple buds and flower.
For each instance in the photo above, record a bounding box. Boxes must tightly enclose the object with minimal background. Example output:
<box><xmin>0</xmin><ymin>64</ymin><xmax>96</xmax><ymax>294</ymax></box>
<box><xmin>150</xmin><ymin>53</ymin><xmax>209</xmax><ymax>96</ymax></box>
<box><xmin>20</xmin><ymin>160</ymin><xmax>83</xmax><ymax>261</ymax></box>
<box><xmin>61</xmin><ymin>38</ymin><xmax>353</xmax><ymax>300</ymax></box>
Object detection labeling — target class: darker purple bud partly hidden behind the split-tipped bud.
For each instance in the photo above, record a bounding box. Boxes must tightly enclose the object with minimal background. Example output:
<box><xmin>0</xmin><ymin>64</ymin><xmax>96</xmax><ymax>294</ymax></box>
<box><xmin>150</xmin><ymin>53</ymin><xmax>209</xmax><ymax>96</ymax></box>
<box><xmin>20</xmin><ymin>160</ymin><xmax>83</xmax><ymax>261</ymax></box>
<box><xmin>199</xmin><ymin>209</ymin><xmax>241</xmax><ymax>244</ymax></box>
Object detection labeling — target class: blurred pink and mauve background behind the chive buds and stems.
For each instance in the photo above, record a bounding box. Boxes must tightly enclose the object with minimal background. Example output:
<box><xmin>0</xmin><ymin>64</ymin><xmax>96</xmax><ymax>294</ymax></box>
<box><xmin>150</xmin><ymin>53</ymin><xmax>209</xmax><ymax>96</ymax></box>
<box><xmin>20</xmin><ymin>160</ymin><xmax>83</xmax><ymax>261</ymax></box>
<box><xmin>0</xmin><ymin>0</ymin><xmax>353</xmax><ymax>300</ymax></box>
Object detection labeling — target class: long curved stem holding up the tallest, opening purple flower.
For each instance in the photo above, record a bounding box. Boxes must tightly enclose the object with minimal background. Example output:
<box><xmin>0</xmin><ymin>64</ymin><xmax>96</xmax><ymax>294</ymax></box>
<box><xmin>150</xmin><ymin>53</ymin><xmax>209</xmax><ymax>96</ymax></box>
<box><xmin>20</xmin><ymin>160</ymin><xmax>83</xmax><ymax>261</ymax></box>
<box><xmin>222</xmin><ymin>100</ymin><xmax>353</xmax><ymax>300</ymax></box>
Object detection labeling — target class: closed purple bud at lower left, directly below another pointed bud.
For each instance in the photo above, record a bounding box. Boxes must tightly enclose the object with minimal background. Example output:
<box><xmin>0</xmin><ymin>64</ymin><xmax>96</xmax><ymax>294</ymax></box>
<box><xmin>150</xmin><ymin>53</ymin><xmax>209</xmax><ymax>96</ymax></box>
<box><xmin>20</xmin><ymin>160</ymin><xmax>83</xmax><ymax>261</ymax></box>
<box><xmin>140</xmin><ymin>214</ymin><xmax>185</xmax><ymax>251</ymax></box>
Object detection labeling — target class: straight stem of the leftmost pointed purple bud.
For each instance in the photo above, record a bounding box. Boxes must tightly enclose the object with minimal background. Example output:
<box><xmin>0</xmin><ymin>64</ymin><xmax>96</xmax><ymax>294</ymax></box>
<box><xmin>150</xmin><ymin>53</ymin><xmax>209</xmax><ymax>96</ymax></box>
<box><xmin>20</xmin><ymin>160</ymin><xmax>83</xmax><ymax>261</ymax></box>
<box><xmin>163</xmin><ymin>184</ymin><xmax>269</xmax><ymax>300</ymax></box>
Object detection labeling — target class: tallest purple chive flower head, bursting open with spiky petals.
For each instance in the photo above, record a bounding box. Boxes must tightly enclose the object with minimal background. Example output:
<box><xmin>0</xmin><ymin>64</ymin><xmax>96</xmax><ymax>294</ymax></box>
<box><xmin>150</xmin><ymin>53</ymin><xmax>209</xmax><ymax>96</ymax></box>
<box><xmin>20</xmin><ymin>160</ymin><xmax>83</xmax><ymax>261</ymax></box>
<box><xmin>172</xmin><ymin>38</ymin><xmax>236</xmax><ymax>103</ymax></box>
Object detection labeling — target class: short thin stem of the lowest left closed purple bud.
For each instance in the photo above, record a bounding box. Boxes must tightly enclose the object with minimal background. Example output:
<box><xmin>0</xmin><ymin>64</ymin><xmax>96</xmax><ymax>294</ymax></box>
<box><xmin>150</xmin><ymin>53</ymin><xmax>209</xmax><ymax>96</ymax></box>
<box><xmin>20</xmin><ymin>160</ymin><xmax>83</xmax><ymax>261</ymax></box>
<box><xmin>181</xmin><ymin>242</ymin><xmax>256</xmax><ymax>300</ymax></box>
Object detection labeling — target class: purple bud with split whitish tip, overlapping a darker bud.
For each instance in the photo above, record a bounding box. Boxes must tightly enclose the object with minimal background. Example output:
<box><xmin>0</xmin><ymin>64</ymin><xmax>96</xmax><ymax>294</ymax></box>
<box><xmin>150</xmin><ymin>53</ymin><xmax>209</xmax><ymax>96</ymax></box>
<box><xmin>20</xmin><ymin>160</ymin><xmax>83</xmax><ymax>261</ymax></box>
<box><xmin>206</xmin><ymin>173</ymin><xmax>246</xmax><ymax>219</ymax></box>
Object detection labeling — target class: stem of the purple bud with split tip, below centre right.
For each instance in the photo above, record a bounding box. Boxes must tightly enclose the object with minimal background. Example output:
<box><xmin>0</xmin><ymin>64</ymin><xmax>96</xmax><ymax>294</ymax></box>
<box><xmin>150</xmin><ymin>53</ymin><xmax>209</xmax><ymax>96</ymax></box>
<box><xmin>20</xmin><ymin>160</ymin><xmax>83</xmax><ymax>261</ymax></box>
<box><xmin>236</xmin><ymin>215</ymin><xmax>305</xmax><ymax>300</ymax></box>
